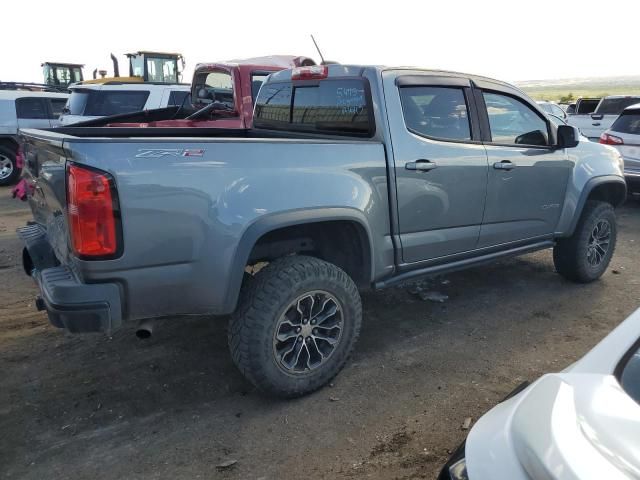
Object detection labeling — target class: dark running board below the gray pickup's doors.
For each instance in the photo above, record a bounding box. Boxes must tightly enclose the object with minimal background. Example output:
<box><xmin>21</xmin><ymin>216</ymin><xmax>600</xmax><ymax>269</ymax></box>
<box><xmin>374</xmin><ymin>240</ymin><xmax>555</xmax><ymax>289</ymax></box>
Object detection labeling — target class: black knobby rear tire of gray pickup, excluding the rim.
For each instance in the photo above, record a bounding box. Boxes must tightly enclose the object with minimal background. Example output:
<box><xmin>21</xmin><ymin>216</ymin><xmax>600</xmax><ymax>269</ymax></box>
<box><xmin>228</xmin><ymin>255</ymin><xmax>362</xmax><ymax>398</ymax></box>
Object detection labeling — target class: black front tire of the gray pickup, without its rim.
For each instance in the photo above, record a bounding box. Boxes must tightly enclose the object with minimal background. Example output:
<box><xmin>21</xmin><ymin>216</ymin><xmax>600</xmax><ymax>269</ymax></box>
<box><xmin>553</xmin><ymin>200</ymin><xmax>617</xmax><ymax>283</ymax></box>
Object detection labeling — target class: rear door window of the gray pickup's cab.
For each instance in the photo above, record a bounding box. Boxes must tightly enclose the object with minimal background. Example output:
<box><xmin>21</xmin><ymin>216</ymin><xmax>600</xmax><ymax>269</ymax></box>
<box><xmin>400</xmin><ymin>86</ymin><xmax>471</xmax><ymax>141</ymax></box>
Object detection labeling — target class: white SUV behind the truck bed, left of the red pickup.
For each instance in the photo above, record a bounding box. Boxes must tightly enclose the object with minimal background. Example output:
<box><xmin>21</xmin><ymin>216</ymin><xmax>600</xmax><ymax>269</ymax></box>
<box><xmin>60</xmin><ymin>82</ymin><xmax>191</xmax><ymax>125</ymax></box>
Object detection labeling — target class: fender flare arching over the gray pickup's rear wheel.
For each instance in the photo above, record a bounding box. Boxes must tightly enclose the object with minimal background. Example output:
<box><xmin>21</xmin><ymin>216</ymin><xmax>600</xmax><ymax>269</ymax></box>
<box><xmin>224</xmin><ymin>207</ymin><xmax>374</xmax><ymax>313</ymax></box>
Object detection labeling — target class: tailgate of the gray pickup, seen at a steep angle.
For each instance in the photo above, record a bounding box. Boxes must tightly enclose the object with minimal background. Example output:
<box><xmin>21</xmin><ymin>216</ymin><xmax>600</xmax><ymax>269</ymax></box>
<box><xmin>21</xmin><ymin>129</ymin><xmax>69</xmax><ymax>261</ymax></box>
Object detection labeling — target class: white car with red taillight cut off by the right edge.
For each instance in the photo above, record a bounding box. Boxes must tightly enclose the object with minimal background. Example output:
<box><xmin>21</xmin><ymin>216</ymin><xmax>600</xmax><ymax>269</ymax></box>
<box><xmin>600</xmin><ymin>103</ymin><xmax>640</xmax><ymax>193</ymax></box>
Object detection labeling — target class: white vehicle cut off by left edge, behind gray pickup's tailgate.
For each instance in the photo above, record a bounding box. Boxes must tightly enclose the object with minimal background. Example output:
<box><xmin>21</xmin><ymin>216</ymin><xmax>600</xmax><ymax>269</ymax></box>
<box><xmin>0</xmin><ymin>90</ymin><xmax>69</xmax><ymax>186</ymax></box>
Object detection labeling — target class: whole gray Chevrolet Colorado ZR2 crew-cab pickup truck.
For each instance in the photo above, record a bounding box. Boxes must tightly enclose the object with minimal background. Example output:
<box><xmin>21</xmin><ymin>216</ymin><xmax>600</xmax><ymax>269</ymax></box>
<box><xmin>19</xmin><ymin>65</ymin><xmax>626</xmax><ymax>397</ymax></box>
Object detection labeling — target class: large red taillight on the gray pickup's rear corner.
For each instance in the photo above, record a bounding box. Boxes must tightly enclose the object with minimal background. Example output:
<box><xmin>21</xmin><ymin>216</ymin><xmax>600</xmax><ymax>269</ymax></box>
<box><xmin>67</xmin><ymin>164</ymin><xmax>118</xmax><ymax>257</ymax></box>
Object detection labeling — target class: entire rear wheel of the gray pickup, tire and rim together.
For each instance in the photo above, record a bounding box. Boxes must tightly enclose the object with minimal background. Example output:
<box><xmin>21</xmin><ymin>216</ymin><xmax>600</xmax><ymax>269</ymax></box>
<box><xmin>228</xmin><ymin>255</ymin><xmax>362</xmax><ymax>398</ymax></box>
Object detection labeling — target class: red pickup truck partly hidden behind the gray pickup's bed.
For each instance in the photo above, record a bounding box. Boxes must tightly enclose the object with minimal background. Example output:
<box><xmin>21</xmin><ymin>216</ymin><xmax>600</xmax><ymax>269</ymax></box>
<box><xmin>111</xmin><ymin>55</ymin><xmax>315</xmax><ymax>129</ymax></box>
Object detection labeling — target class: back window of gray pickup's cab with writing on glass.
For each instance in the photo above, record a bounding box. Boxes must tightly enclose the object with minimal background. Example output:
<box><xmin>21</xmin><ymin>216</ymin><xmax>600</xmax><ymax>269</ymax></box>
<box><xmin>253</xmin><ymin>78</ymin><xmax>375</xmax><ymax>136</ymax></box>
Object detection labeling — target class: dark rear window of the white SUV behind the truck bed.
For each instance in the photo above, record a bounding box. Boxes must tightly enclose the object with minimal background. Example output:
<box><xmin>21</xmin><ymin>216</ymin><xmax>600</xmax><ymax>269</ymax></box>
<box><xmin>65</xmin><ymin>90</ymin><xmax>149</xmax><ymax>117</ymax></box>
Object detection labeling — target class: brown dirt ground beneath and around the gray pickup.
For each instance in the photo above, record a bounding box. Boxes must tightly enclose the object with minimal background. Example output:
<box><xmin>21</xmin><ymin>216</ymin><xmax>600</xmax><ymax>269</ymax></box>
<box><xmin>0</xmin><ymin>188</ymin><xmax>640</xmax><ymax>480</ymax></box>
